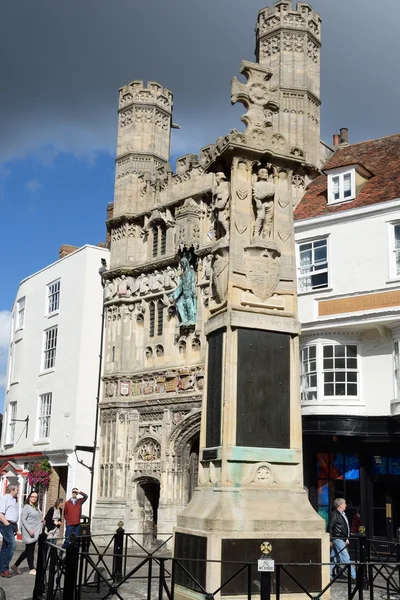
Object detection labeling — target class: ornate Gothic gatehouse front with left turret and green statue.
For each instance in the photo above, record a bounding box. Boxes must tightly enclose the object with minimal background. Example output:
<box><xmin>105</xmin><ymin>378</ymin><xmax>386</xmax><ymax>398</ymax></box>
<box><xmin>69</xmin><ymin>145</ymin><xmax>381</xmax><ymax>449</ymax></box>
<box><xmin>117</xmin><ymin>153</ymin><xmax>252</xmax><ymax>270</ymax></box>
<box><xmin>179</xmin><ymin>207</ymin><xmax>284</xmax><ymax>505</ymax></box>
<box><xmin>94</xmin><ymin>81</ymin><xmax>213</xmax><ymax>543</ymax></box>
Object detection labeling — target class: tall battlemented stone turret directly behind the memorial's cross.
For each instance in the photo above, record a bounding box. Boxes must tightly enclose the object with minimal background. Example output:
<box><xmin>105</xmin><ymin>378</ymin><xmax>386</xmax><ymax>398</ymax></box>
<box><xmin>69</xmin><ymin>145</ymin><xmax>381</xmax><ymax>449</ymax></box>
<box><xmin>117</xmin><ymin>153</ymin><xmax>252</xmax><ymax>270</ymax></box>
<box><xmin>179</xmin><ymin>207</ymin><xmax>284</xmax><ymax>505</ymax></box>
<box><xmin>256</xmin><ymin>0</ymin><xmax>321</xmax><ymax>166</ymax></box>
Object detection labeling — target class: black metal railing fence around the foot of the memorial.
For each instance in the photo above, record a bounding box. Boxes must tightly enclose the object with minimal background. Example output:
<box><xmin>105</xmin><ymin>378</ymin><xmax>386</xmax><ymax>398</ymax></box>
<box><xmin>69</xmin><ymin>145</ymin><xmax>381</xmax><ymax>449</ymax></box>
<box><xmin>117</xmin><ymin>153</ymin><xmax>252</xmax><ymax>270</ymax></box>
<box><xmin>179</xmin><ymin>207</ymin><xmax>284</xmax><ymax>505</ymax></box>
<box><xmin>32</xmin><ymin>528</ymin><xmax>400</xmax><ymax>600</ymax></box>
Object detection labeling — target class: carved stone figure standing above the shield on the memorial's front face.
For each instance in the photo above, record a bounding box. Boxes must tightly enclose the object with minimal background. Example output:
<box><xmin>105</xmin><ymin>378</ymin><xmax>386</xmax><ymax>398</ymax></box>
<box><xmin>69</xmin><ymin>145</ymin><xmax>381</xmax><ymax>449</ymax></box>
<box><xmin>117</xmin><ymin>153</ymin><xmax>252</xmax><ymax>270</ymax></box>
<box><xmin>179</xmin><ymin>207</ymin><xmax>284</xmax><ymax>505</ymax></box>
<box><xmin>253</xmin><ymin>169</ymin><xmax>275</xmax><ymax>237</ymax></box>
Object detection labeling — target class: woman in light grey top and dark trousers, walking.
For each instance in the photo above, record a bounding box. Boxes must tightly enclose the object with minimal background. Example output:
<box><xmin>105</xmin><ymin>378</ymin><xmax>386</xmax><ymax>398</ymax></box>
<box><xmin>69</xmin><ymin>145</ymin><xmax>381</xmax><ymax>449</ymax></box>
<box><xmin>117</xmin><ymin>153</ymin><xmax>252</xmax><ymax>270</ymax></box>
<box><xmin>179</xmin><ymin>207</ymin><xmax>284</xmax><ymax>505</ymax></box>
<box><xmin>11</xmin><ymin>492</ymin><xmax>44</xmax><ymax>575</ymax></box>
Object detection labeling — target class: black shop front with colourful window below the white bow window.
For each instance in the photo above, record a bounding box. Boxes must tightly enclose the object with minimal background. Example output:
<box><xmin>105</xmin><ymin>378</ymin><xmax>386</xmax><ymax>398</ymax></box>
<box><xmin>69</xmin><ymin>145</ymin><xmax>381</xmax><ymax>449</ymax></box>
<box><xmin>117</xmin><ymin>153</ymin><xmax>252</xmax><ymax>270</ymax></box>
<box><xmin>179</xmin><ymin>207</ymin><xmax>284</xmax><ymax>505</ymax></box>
<box><xmin>303</xmin><ymin>415</ymin><xmax>400</xmax><ymax>541</ymax></box>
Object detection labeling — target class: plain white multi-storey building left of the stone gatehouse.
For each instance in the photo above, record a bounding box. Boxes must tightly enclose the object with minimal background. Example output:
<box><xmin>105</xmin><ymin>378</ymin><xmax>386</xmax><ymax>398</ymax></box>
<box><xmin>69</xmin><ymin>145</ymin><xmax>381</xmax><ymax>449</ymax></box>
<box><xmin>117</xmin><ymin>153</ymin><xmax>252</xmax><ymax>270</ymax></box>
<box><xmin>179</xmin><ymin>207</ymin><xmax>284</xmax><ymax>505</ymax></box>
<box><xmin>0</xmin><ymin>241</ymin><xmax>109</xmax><ymax>528</ymax></box>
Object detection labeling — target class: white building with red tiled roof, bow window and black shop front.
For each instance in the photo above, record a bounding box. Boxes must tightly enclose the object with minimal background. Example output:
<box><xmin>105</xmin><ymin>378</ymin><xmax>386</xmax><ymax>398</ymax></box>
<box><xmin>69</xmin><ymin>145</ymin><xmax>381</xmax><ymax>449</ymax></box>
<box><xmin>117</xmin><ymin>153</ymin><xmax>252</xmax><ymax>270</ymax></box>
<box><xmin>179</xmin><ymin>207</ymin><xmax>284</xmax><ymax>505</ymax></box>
<box><xmin>295</xmin><ymin>135</ymin><xmax>400</xmax><ymax>540</ymax></box>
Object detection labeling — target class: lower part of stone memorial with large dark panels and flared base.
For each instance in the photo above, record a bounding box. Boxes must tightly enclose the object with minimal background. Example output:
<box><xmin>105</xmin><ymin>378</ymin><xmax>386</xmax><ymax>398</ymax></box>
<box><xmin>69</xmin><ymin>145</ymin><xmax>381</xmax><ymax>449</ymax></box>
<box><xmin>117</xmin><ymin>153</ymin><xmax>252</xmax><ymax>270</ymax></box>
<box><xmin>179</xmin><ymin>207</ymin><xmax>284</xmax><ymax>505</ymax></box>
<box><xmin>174</xmin><ymin>310</ymin><xmax>329</xmax><ymax>598</ymax></box>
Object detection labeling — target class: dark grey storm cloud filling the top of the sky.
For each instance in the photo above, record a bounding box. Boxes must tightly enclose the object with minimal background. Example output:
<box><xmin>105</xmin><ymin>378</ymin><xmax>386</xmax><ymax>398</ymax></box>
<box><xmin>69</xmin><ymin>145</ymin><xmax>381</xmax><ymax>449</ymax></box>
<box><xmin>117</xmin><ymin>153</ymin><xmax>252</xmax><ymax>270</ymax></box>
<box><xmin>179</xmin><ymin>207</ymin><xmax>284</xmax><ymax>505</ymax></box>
<box><xmin>0</xmin><ymin>0</ymin><xmax>400</xmax><ymax>160</ymax></box>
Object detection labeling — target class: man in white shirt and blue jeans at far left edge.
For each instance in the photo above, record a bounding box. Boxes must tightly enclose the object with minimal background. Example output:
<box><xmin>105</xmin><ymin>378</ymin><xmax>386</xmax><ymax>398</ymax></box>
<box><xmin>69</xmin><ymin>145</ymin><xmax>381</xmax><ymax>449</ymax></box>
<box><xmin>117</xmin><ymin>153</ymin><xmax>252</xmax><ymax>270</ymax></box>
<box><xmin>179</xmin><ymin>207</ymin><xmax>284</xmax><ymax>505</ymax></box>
<box><xmin>0</xmin><ymin>483</ymin><xmax>19</xmax><ymax>577</ymax></box>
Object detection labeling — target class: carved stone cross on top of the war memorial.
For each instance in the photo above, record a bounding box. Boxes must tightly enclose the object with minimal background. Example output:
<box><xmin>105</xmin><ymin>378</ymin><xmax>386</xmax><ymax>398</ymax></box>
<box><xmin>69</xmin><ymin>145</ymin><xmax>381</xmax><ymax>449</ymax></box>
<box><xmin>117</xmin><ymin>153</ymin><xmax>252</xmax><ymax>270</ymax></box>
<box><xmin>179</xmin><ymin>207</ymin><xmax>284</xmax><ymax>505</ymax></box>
<box><xmin>231</xmin><ymin>61</ymin><xmax>279</xmax><ymax>132</ymax></box>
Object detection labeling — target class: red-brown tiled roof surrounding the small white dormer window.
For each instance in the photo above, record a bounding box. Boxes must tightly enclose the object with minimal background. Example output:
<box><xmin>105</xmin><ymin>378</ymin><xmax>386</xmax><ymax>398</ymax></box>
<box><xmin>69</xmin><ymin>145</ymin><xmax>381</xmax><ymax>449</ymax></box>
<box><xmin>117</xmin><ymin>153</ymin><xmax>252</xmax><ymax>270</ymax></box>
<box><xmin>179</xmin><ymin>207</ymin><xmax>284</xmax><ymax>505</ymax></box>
<box><xmin>294</xmin><ymin>134</ymin><xmax>400</xmax><ymax>221</ymax></box>
